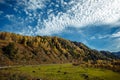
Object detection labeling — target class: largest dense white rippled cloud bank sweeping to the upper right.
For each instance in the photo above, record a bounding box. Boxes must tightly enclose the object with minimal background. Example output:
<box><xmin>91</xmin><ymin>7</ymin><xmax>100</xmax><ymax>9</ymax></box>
<box><xmin>28</xmin><ymin>0</ymin><xmax>120</xmax><ymax>35</ymax></box>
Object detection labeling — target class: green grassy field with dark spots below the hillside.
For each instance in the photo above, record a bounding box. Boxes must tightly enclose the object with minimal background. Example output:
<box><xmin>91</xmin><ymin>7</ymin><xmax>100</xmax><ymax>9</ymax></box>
<box><xmin>0</xmin><ymin>64</ymin><xmax>120</xmax><ymax>80</ymax></box>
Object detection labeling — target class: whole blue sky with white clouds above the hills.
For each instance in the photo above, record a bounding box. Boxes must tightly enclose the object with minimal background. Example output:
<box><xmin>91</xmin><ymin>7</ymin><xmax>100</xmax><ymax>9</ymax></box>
<box><xmin>0</xmin><ymin>0</ymin><xmax>120</xmax><ymax>52</ymax></box>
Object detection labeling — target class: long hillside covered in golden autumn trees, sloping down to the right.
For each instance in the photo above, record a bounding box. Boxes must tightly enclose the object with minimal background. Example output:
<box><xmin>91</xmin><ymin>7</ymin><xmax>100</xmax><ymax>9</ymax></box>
<box><xmin>0</xmin><ymin>32</ymin><xmax>118</xmax><ymax>66</ymax></box>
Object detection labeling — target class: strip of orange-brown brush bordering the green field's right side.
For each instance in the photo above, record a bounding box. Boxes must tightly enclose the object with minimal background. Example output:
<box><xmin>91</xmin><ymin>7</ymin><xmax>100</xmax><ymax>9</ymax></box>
<box><xmin>72</xmin><ymin>60</ymin><xmax>120</xmax><ymax>72</ymax></box>
